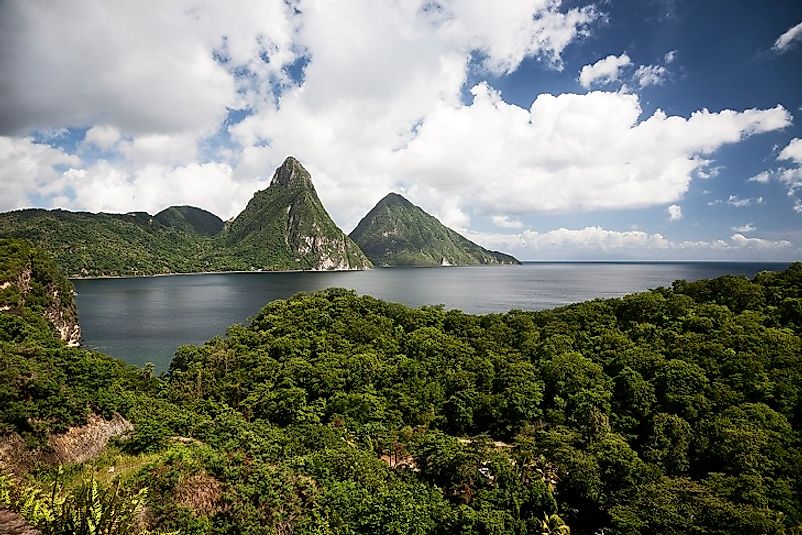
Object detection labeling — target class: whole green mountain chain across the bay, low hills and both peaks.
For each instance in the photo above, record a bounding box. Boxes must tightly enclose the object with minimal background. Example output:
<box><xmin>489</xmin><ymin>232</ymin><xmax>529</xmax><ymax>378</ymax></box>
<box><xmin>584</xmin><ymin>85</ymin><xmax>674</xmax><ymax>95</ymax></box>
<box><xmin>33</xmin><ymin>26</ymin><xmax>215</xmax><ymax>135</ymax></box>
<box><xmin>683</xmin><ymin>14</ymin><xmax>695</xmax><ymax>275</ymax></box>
<box><xmin>0</xmin><ymin>156</ymin><xmax>520</xmax><ymax>277</ymax></box>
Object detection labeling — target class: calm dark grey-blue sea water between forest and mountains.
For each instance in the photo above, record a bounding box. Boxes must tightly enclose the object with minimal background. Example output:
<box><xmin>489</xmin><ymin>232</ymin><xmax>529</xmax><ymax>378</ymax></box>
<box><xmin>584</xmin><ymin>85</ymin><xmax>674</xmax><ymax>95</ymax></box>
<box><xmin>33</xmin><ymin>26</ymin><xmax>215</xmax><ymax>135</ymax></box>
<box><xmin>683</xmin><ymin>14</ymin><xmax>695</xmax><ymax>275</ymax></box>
<box><xmin>73</xmin><ymin>262</ymin><xmax>787</xmax><ymax>371</ymax></box>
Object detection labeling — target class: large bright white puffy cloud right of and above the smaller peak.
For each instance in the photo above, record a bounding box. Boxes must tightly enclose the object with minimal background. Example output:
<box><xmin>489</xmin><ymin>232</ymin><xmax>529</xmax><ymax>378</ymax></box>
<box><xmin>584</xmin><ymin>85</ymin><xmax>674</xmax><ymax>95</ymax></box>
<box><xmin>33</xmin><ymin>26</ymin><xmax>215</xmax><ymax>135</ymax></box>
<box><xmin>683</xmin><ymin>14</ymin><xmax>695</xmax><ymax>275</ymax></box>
<box><xmin>384</xmin><ymin>89</ymin><xmax>790</xmax><ymax>226</ymax></box>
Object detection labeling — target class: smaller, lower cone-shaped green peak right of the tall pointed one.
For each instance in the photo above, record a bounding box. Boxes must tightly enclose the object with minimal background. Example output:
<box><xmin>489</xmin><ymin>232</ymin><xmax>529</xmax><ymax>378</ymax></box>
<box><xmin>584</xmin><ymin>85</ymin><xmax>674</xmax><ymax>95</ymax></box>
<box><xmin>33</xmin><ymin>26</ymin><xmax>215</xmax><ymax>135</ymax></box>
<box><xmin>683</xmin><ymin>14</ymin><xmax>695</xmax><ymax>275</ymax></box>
<box><xmin>350</xmin><ymin>193</ymin><xmax>520</xmax><ymax>266</ymax></box>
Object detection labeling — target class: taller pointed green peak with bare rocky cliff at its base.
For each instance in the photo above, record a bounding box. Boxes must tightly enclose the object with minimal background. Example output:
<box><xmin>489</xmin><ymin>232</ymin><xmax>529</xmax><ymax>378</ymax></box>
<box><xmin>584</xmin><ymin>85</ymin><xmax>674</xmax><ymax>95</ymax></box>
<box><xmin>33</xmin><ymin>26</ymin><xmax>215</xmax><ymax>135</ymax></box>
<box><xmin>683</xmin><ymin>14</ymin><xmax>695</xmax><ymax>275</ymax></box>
<box><xmin>216</xmin><ymin>157</ymin><xmax>371</xmax><ymax>270</ymax></box>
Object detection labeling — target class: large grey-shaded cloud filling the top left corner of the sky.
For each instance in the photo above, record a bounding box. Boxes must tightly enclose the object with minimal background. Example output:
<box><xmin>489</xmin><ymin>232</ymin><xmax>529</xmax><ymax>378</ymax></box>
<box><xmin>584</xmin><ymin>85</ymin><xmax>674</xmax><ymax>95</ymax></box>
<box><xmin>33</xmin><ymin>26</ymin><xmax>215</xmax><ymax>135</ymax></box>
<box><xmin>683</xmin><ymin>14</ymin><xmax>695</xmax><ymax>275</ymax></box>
<box><xmin>0</xmin><ymin>0</ymin><xmax>295</xmax><ymax>134</ymax></box>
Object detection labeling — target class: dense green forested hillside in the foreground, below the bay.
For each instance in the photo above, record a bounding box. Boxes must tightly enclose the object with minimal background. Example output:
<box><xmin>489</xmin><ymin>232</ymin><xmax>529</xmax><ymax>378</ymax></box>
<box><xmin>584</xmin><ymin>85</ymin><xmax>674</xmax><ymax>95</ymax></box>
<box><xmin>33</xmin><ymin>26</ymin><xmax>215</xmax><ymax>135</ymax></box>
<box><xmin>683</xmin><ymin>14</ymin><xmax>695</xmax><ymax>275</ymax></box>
<box><xmin>0</xmin><ymin>240</ymin><xmax>802</xmax><ymax>534</ymax></box>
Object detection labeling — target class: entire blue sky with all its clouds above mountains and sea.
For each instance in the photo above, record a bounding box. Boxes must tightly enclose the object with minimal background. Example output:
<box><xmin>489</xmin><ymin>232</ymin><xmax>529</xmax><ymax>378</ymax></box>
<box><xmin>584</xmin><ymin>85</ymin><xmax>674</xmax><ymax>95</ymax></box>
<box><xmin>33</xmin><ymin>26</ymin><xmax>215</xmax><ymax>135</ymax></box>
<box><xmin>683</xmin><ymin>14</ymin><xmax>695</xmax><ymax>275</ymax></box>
<box><xmin>0</xmin><ymin>0</ymin><xmax>802</xmax><ymax>261</ymax></box>
